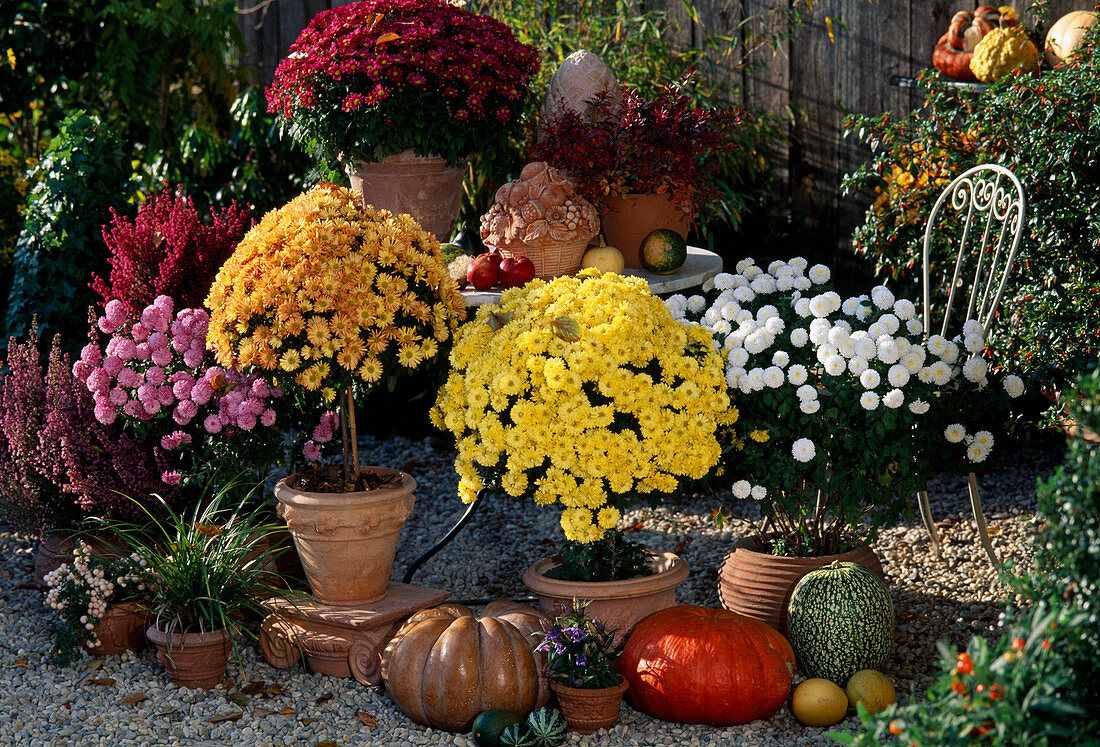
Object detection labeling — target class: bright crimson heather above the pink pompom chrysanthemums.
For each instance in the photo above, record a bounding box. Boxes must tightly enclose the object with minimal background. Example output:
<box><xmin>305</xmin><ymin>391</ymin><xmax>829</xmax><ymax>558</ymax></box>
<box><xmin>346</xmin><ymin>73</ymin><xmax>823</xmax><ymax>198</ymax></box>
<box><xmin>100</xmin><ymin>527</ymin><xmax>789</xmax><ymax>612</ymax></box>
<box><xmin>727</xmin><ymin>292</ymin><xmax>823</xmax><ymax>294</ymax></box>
<box><xmin>91</xmin><ymin>188</ymin><xmax>252</xmax><ymax>316</ymax></box>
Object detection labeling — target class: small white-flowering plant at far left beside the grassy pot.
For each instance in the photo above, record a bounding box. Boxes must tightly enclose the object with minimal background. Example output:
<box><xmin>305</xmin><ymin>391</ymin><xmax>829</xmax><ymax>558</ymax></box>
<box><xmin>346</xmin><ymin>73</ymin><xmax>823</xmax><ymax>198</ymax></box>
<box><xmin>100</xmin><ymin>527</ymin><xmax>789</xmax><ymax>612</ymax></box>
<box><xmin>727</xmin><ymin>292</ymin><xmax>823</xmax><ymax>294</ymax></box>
<box><xmin>45</xmin><ymin>540</ymin><xmax>146</xmax><ymax>667</ymax></box>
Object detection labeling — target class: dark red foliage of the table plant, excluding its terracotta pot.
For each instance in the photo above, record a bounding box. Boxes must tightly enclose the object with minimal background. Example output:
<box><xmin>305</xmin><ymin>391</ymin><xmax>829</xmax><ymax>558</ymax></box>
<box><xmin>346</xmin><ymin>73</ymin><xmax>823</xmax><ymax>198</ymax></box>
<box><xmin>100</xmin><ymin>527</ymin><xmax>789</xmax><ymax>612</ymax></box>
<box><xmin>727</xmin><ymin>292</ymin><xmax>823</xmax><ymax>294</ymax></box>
<box><xmin>530</xmin><ymin>84</ymin><xmax>747</xmax><ymax>216</ymax></box>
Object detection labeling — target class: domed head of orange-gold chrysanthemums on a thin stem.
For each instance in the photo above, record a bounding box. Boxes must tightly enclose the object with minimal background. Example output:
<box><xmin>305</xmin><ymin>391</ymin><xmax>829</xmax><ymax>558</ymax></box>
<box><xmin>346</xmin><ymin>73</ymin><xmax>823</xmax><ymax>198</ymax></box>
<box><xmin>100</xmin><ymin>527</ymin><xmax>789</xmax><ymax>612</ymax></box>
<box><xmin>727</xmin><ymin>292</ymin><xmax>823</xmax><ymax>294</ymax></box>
<box><xmin>206</xmin><ymin>184</ymin><xmax>465</xmax><ymax>402</ymax></box>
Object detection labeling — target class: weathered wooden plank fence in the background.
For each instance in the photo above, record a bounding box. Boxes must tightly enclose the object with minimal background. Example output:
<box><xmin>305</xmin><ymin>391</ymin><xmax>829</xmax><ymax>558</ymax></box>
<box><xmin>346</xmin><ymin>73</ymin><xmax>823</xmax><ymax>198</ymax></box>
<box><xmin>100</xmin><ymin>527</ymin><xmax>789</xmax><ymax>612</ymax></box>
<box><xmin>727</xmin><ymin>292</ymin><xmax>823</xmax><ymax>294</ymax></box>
<box><xmin>238</xmin><ymin>0</ymin><xmax>1091</xmax><ymax>266</ymax></box>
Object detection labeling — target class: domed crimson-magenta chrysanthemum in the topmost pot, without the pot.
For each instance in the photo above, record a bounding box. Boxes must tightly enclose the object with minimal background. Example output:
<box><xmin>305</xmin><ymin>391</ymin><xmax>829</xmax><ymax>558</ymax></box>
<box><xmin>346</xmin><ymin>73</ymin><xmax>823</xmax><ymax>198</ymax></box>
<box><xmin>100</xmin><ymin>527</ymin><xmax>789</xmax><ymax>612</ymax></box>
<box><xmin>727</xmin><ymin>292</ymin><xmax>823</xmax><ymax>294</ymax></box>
<box><xmin>267</xmin><ymin>0</ymin><xmax>539</xmax><ymax>165</ymax></box>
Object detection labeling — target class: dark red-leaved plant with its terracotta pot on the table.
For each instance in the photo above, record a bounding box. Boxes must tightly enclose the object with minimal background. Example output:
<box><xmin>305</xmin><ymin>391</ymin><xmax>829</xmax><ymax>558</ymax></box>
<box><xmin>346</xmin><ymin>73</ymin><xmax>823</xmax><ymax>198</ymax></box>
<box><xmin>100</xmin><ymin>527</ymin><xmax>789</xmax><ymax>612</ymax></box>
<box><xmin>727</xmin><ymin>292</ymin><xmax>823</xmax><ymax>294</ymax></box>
<box><xmin>531</xmin><ymin>81</ymin><xmax>744</xmax><ymax>267</ymax></box>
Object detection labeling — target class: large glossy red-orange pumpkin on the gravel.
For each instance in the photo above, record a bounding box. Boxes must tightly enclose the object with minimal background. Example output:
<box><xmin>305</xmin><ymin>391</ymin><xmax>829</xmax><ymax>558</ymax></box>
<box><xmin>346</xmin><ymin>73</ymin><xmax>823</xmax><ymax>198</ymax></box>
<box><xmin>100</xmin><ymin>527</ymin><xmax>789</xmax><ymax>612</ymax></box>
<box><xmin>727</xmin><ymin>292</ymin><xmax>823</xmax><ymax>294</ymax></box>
<box><xmin>619</xmin><ymin>604</ymin><xmax>794</xmax><ymax>726</ymax></box>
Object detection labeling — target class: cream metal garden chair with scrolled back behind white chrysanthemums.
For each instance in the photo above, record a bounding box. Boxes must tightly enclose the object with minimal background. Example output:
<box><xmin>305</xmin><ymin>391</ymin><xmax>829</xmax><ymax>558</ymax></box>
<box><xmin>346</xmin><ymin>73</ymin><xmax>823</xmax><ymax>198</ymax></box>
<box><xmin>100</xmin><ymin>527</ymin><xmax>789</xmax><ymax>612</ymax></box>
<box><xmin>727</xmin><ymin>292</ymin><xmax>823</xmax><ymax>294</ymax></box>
<box><xmin>916</xmin><ymin>164</ymin><xmax>1025</xmax><ymax>567</ymax></box>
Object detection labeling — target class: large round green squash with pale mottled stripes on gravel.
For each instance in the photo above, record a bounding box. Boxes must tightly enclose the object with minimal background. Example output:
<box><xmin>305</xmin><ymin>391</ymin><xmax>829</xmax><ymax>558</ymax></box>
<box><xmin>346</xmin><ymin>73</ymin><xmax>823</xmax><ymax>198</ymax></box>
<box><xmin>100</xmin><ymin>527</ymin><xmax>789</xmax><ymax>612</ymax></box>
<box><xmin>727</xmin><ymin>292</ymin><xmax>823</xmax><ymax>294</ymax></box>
<box><xmin>787</xmin><ymin>560</ymin><xmax>894</xmax><ymax>688</ymax></box>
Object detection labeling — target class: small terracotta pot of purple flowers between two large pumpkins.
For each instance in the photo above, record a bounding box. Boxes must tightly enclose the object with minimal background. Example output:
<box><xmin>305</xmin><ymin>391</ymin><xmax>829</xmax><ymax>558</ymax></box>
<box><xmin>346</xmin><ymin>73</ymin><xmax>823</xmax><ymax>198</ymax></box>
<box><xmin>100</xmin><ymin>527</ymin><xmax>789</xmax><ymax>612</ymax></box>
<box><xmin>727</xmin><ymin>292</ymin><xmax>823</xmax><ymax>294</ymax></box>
<box><xmin>535</xmin><ymin>600</ymin><xmax>627</xmax><ymax>734</ymax></box>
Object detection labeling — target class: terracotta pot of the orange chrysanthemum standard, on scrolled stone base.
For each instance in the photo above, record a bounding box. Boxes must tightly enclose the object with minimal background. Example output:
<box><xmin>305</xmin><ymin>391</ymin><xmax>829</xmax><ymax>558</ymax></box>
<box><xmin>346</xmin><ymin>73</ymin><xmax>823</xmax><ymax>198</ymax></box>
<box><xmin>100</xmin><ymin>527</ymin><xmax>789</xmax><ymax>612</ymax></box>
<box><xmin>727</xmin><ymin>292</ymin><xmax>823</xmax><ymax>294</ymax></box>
<box><xmin>275</xmin><ymin>466</ymin><xmax>416</xmax><ymax>606</ymax></box>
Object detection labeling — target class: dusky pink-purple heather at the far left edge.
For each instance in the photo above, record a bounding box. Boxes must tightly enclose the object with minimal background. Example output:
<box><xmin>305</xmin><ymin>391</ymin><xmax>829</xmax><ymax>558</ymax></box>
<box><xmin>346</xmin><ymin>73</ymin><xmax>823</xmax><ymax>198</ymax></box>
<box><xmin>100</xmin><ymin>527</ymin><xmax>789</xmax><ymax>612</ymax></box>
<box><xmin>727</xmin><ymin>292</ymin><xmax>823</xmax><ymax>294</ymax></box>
<box><xmin>0</xmin><ymin>337</ymin><xmax>162</xmax><ymax>532</ymax></box>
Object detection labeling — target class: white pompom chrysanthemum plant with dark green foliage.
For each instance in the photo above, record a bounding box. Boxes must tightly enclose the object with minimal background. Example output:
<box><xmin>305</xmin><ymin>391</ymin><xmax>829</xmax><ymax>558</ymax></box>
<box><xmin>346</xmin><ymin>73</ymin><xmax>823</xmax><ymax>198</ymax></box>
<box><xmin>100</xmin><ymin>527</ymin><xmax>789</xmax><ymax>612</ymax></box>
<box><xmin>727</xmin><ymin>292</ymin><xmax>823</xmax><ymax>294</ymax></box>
<box><xmin>666</xmin><ymin>257</ymin><xmax>1023</xmax><ymax>556</ymax></box>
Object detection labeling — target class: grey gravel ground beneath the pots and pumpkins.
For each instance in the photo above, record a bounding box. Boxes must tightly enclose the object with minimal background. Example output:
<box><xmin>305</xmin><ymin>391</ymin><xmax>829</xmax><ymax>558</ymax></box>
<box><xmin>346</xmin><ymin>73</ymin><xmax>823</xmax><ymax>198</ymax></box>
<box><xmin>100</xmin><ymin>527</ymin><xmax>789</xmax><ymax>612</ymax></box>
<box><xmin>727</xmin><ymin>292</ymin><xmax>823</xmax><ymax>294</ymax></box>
<box><xmin>0</xmin><ymin>438</ymin><xmax>1062</xmax><ymax>747</ymax></box>
